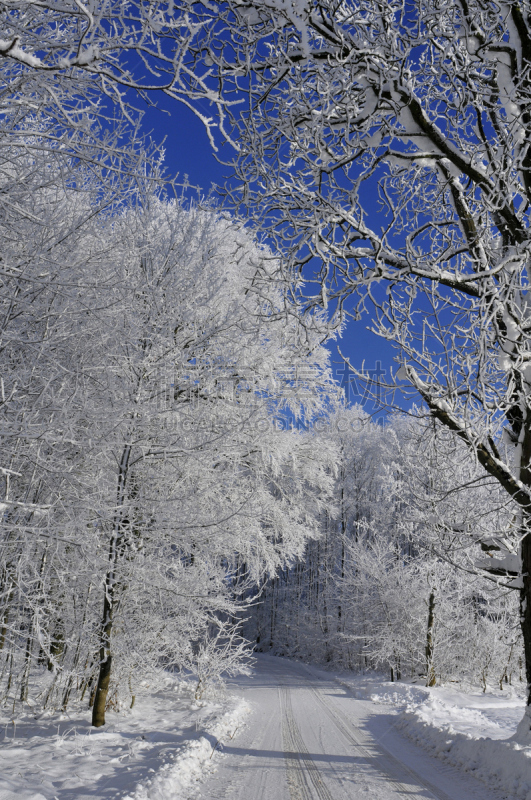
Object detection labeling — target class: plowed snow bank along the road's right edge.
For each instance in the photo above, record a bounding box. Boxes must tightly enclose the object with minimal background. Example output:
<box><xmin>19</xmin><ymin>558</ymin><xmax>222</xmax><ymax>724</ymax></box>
<box><xmin>397</xmin><ymin>692</ymin><xmax>531</xmax><ymax>800</ymax></box>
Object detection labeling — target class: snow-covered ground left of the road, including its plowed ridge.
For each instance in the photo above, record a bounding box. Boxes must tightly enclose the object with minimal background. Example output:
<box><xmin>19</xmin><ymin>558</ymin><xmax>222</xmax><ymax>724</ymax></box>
<box><xmin>0</xmin><ymin>676</ymin><xmax>249</xmax><ymax>800</ymax></box>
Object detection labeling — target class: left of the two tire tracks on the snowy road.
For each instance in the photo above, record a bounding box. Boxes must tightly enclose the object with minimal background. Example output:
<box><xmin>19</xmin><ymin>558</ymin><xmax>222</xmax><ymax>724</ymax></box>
<box><xmin>280</xmin><ymin>686</ymin><xmax>334</xmax><ymax>800</ymax></box>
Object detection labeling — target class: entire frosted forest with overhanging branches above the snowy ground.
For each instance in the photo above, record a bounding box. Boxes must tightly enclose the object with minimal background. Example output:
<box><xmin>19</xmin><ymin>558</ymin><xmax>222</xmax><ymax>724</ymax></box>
<box><xmin>0</xmin><ymin>0</ymin><xmax>531</xmax><ymax>744</ymax></box>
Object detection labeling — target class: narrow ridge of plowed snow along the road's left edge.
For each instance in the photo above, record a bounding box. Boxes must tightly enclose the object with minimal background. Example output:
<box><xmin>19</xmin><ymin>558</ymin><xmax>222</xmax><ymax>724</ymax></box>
<box><xmin>123</xmin><ymin>698</ymin><xmax>250</xmax><ymax>800</ymax></box>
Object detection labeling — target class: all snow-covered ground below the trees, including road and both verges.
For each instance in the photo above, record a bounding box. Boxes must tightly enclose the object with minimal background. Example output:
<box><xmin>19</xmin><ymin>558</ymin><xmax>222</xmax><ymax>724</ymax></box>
<box><xmin>4</xmin><ymin>656</ymin><xmax>531</xmax><ymax>800</ymax></box>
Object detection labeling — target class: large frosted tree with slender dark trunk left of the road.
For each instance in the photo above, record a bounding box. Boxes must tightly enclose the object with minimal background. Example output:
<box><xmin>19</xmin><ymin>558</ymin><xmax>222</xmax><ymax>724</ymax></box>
<box><xmin>80</xmin><ymin>200</ymin><xmax>334</xmax><ymax>725</ymax></box>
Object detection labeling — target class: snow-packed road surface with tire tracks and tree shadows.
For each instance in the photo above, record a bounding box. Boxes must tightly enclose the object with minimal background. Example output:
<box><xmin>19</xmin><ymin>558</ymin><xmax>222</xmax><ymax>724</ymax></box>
<box><xmin>200</xmin><ymin>656</ymin><xmax>510</xmax><ymax>800</ymax></box>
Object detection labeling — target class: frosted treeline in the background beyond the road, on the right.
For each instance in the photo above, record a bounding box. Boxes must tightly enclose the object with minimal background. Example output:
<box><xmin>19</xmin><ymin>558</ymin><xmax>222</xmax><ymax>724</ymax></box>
<box><xmin>245</xmin><ymin>408</ymin><xmax>525</xmax><ymax>688</ymax></box>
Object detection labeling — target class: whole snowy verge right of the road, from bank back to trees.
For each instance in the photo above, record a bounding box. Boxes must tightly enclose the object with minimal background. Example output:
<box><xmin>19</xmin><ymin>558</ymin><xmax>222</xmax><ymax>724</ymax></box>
<box><xmin>300</xmin><ymin>668</ymin><xmax>531</xmax><ymax>800</ymax></box>
